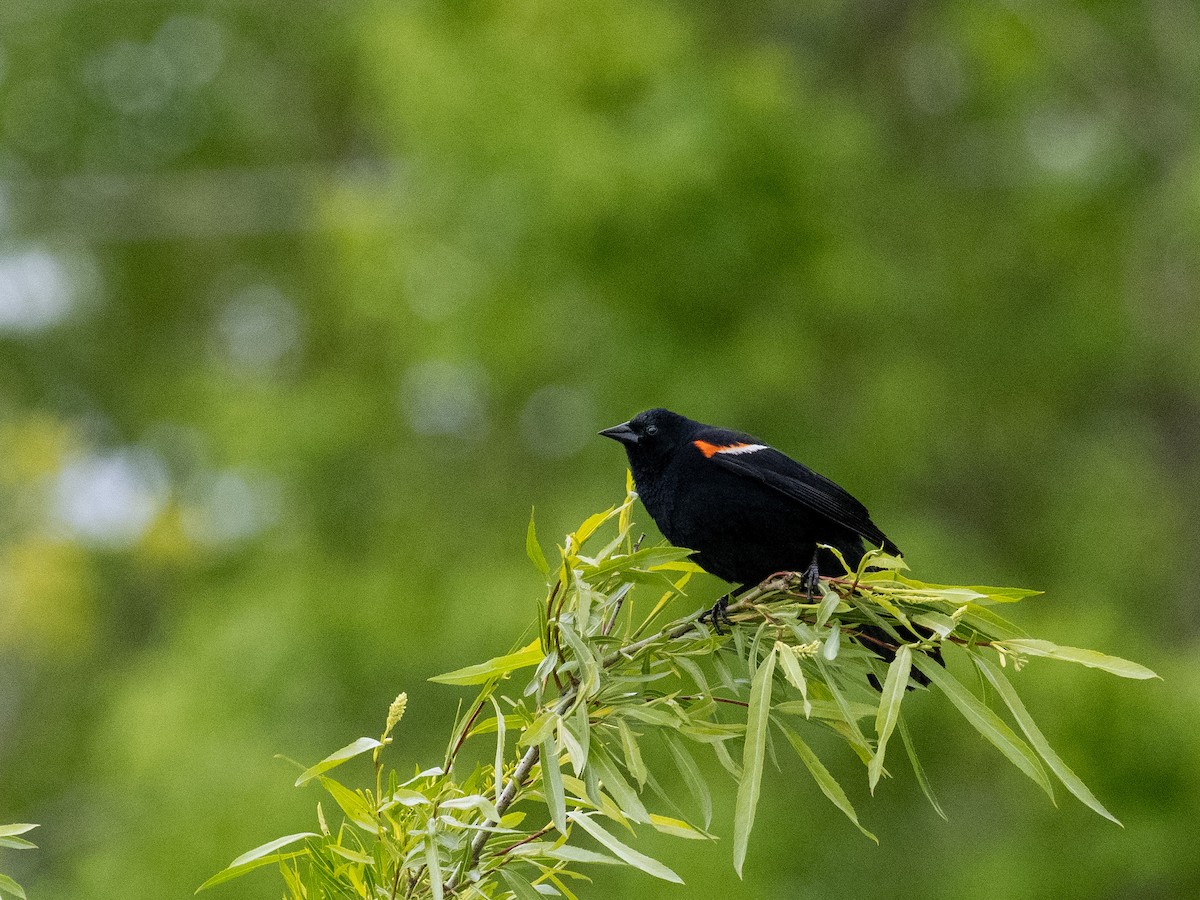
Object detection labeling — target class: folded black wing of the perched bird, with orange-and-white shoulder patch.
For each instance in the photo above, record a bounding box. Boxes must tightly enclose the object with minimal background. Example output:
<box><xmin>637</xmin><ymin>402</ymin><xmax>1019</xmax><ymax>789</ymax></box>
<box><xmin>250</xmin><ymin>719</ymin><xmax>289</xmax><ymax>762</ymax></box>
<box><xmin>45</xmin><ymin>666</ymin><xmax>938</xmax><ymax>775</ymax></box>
<box><xmin>708</xmin><ymin>444</ymin><xmax>900</xmax><ymax>553</ymax></box>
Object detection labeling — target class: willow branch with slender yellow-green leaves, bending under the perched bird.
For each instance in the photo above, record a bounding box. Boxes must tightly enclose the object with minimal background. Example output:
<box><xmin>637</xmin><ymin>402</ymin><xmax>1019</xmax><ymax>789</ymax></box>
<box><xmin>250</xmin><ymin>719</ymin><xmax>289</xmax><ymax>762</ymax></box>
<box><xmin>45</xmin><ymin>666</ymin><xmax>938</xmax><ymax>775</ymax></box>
<box><xmin>200</xmin><ymin>475</ymin><xmax>1154</xmax><ymax>900</ymax></box>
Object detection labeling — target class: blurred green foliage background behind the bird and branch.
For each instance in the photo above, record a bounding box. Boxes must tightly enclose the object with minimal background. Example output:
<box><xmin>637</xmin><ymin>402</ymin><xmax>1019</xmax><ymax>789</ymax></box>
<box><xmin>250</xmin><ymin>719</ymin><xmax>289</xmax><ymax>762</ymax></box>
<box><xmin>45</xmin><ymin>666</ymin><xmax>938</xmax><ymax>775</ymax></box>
<box><xmin>0</xmin><ymin>0</ymin><xmax>1200</xmax><ymax>900</ymax></box>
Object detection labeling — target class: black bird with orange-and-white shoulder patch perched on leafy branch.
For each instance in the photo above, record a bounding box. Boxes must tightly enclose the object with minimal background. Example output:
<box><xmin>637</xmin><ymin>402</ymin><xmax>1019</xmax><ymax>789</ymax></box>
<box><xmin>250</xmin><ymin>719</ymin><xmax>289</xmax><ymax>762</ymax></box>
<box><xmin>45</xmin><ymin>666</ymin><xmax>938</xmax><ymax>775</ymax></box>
<box><xmin>600</xmin><ymin>409</ymin><xmax>924</xmax><ymax>680</ymax></box>
